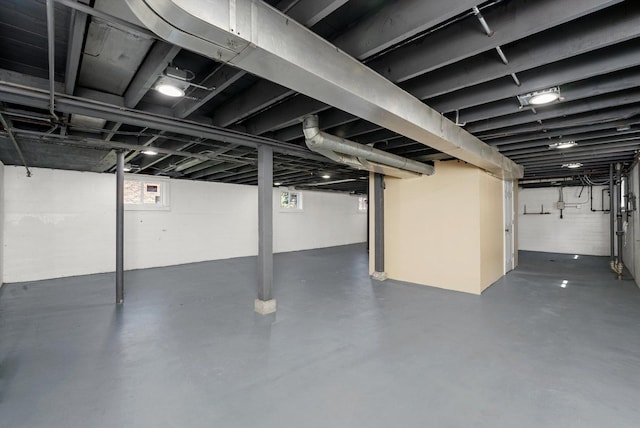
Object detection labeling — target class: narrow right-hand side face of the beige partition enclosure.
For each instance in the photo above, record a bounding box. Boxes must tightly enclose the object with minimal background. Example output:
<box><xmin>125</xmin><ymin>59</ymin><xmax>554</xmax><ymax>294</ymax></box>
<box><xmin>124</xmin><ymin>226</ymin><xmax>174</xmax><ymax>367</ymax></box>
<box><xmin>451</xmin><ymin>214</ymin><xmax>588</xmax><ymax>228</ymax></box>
<box><xmin>478</xmin><ymin>171</ymin><xmax>505</xmax><ymax>291</ymax></box>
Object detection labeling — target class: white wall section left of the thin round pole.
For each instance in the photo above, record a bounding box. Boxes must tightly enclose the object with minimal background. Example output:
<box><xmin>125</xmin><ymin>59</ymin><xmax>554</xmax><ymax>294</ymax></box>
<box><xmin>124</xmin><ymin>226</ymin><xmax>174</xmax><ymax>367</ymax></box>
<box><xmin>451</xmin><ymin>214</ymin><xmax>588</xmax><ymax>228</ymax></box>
<box><xmin>4</xmin><ymin>166</ymin><xmax>116</xmax><ymax>282</ymax></box>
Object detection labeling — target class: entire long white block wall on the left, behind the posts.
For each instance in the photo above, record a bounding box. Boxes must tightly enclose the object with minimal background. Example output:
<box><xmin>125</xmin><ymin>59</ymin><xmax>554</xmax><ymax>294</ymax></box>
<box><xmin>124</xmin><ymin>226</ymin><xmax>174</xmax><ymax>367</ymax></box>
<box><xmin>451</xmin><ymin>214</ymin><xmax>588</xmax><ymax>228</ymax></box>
<box><xmin>3</xmin><ymin>166</ymin><xmax>367</xmax><ymax>282</ymax></box>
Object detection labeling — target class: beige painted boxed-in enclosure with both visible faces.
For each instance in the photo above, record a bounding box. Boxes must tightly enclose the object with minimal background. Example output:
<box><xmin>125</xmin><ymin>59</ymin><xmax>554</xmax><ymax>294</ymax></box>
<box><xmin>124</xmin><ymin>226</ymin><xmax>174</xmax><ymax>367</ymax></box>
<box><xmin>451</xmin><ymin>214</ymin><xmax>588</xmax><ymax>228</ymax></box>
<box><xmin>384</xmin><ymin>161</ymin><xmax>504</xmax><ymax>294</ymax></box>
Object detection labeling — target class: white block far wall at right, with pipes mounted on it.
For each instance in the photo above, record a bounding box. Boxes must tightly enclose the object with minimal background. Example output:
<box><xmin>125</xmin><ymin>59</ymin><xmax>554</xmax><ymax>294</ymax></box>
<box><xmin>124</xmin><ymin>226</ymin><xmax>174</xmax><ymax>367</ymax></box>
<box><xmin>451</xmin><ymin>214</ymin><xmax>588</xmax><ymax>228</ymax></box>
<box><xmin>518</xmin><ymin>186</ymin><xmax>610</xmax><ymax>256</ymax></box>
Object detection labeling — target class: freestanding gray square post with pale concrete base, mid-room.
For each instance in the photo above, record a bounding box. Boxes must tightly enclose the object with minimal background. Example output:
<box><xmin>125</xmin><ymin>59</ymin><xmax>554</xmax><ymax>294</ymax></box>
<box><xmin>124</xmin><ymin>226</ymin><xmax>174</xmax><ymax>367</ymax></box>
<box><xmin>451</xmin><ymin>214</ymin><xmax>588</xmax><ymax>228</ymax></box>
<box><xmin>254</xmin><ymin>145</ymin><xmax>276</xmax><ymax>315</ymax></box>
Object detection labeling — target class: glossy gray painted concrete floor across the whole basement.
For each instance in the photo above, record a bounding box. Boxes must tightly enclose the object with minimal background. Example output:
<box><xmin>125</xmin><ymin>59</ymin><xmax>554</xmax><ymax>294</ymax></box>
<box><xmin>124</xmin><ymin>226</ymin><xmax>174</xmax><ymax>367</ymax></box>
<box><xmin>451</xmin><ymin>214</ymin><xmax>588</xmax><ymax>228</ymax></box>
<box><xmin>0</xmin><ymin>245</ymin><xmax>640</xmax><ymax>428</ymax></box>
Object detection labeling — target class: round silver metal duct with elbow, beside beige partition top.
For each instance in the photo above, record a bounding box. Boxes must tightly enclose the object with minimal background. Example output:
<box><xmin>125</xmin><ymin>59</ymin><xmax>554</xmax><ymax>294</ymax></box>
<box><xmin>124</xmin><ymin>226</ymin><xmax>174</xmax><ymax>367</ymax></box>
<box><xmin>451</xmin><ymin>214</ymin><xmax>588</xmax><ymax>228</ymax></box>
<box><xmin>302</xmin><ymin>115</ymin><xmax>434</xmax><ymax>178</ymax></box>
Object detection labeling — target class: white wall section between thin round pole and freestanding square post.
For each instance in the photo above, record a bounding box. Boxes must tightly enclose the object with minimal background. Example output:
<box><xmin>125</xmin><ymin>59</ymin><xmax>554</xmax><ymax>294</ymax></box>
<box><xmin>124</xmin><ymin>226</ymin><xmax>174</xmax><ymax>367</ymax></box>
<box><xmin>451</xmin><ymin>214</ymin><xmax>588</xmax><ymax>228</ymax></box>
<box><xmin>125</xmin><ymin>177</ymin><xmax>258</xmax><ymax>270</ymax></box>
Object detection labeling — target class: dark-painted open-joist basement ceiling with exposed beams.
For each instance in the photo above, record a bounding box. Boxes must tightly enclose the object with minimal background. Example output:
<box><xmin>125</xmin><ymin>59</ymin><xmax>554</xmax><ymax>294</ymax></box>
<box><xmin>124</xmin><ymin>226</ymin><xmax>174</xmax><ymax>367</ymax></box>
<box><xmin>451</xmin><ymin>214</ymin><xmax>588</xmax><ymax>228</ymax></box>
<box><xmin>0</xmin><ymin>0</ymin><xmax>640</xmax><ymax>192</ymax></box>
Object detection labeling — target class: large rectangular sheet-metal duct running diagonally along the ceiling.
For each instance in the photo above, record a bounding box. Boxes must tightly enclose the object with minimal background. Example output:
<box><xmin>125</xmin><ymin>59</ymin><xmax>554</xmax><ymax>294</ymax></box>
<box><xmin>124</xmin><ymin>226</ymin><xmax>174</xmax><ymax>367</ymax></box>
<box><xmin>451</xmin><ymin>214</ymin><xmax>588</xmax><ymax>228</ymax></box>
<box><xmin>126</xmin><ymin>0</ymin><xmax>523</xmax><ymax>179</ymax></box>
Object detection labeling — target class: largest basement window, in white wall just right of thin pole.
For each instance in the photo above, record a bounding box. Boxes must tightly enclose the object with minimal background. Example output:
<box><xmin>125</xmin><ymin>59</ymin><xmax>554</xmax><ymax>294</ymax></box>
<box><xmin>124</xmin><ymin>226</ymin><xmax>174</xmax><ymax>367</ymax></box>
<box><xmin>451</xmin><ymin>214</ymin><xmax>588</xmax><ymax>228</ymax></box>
<box><xmin>124</xmin><ymin>175</ymin><xmax>170</xmax><ymax>210</ymax></box>
